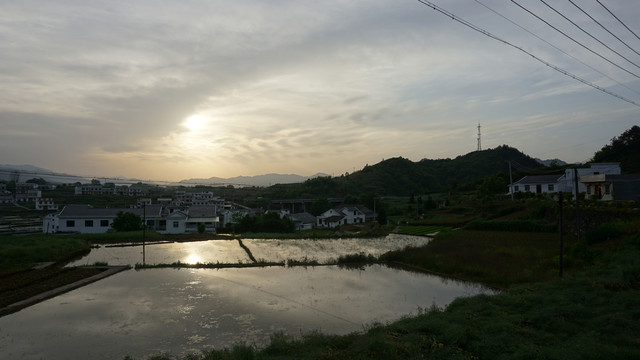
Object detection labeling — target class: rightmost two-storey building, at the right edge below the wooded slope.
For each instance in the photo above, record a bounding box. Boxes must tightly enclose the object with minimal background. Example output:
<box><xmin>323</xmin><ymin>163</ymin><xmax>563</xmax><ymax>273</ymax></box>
<box><xmin>578</xmin><ymin>174</ymin><xmax>640</xmax><ymax>201</ymax></box>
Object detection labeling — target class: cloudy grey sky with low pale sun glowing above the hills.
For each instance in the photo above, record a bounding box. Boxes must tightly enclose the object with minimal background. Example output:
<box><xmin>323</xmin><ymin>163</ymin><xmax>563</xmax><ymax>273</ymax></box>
<box><xmin>0</xmin><ymin>0</ymin><xmax>640</xmax><ymax>181</ymax></box>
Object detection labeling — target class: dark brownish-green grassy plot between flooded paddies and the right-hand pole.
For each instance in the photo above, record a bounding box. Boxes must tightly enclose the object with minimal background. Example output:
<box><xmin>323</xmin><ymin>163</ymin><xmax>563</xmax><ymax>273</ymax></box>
<box><xmin>381</xmin><ymin>230</ymin><xmax>578</xmax><ymax>288</ymax></box>
